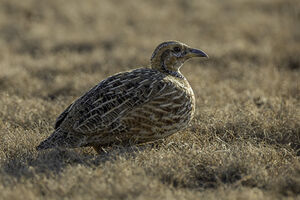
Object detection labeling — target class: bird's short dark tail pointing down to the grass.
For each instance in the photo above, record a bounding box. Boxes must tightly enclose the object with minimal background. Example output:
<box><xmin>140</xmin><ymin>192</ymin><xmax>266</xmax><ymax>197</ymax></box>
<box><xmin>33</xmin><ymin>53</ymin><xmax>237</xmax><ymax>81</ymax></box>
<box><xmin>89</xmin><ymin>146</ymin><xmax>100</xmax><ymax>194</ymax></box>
<box><xmin>36</xmin><ymin>128</ymin><xmax>83</xmax><ymax>150</ymax></box>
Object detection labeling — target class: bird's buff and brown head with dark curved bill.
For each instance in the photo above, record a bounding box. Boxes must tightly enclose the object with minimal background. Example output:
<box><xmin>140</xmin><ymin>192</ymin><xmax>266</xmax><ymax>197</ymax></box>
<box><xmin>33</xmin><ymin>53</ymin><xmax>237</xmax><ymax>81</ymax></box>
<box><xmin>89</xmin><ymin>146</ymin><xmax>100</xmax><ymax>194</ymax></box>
<box><xmin>151</xmin><ymin>41</ymin><xmax>208</xmax><ymax>77</ymax></box>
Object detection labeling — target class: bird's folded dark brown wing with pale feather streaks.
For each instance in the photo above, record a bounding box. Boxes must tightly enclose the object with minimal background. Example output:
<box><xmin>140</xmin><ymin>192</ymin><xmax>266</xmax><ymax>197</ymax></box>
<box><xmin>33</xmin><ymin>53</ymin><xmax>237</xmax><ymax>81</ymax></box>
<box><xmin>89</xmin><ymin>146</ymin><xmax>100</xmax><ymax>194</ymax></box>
<box><xmin>73</xmin><ymin>69</ymin><xmax>169</xmax><ymax>134</ymax></box>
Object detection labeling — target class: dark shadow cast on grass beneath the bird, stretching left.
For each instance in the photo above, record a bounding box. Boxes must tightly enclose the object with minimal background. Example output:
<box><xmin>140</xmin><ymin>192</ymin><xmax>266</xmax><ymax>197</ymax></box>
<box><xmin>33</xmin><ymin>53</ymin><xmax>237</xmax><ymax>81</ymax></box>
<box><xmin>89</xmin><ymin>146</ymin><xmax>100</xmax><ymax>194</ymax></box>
<box><xmin>0</xmin><ymin>147</ymin><xmax>144</xmax><ymax>179</ymax></box>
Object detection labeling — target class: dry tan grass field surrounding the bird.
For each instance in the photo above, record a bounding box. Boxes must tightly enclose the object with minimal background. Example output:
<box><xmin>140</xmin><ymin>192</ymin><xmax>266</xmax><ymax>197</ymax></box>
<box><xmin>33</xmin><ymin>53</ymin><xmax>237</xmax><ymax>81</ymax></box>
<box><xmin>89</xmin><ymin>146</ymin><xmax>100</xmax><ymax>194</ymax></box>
<box><xmin>0</xmin><ymin>0</ymin><xmax>300</xmax><ymax>200</ymax></box>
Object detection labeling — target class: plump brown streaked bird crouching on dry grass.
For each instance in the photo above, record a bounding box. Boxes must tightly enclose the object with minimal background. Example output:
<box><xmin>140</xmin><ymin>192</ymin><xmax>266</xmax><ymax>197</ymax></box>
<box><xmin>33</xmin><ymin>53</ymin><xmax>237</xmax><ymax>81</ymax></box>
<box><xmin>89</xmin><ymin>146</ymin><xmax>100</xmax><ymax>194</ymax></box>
<box><xmin>36</xmin><ymin>41</ymin><xmax>208</xmax><ymax>153</ymax></box>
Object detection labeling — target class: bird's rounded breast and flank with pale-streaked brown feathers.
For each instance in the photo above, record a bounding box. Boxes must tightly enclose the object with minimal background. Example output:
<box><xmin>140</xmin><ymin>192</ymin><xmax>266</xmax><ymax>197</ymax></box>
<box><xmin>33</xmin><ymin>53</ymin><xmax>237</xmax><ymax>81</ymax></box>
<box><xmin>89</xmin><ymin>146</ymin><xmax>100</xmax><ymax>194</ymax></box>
<box><xmin>123</xmin><ymin>76</ymin><xmax>195</xmax><ymax>141</ymax></box>
